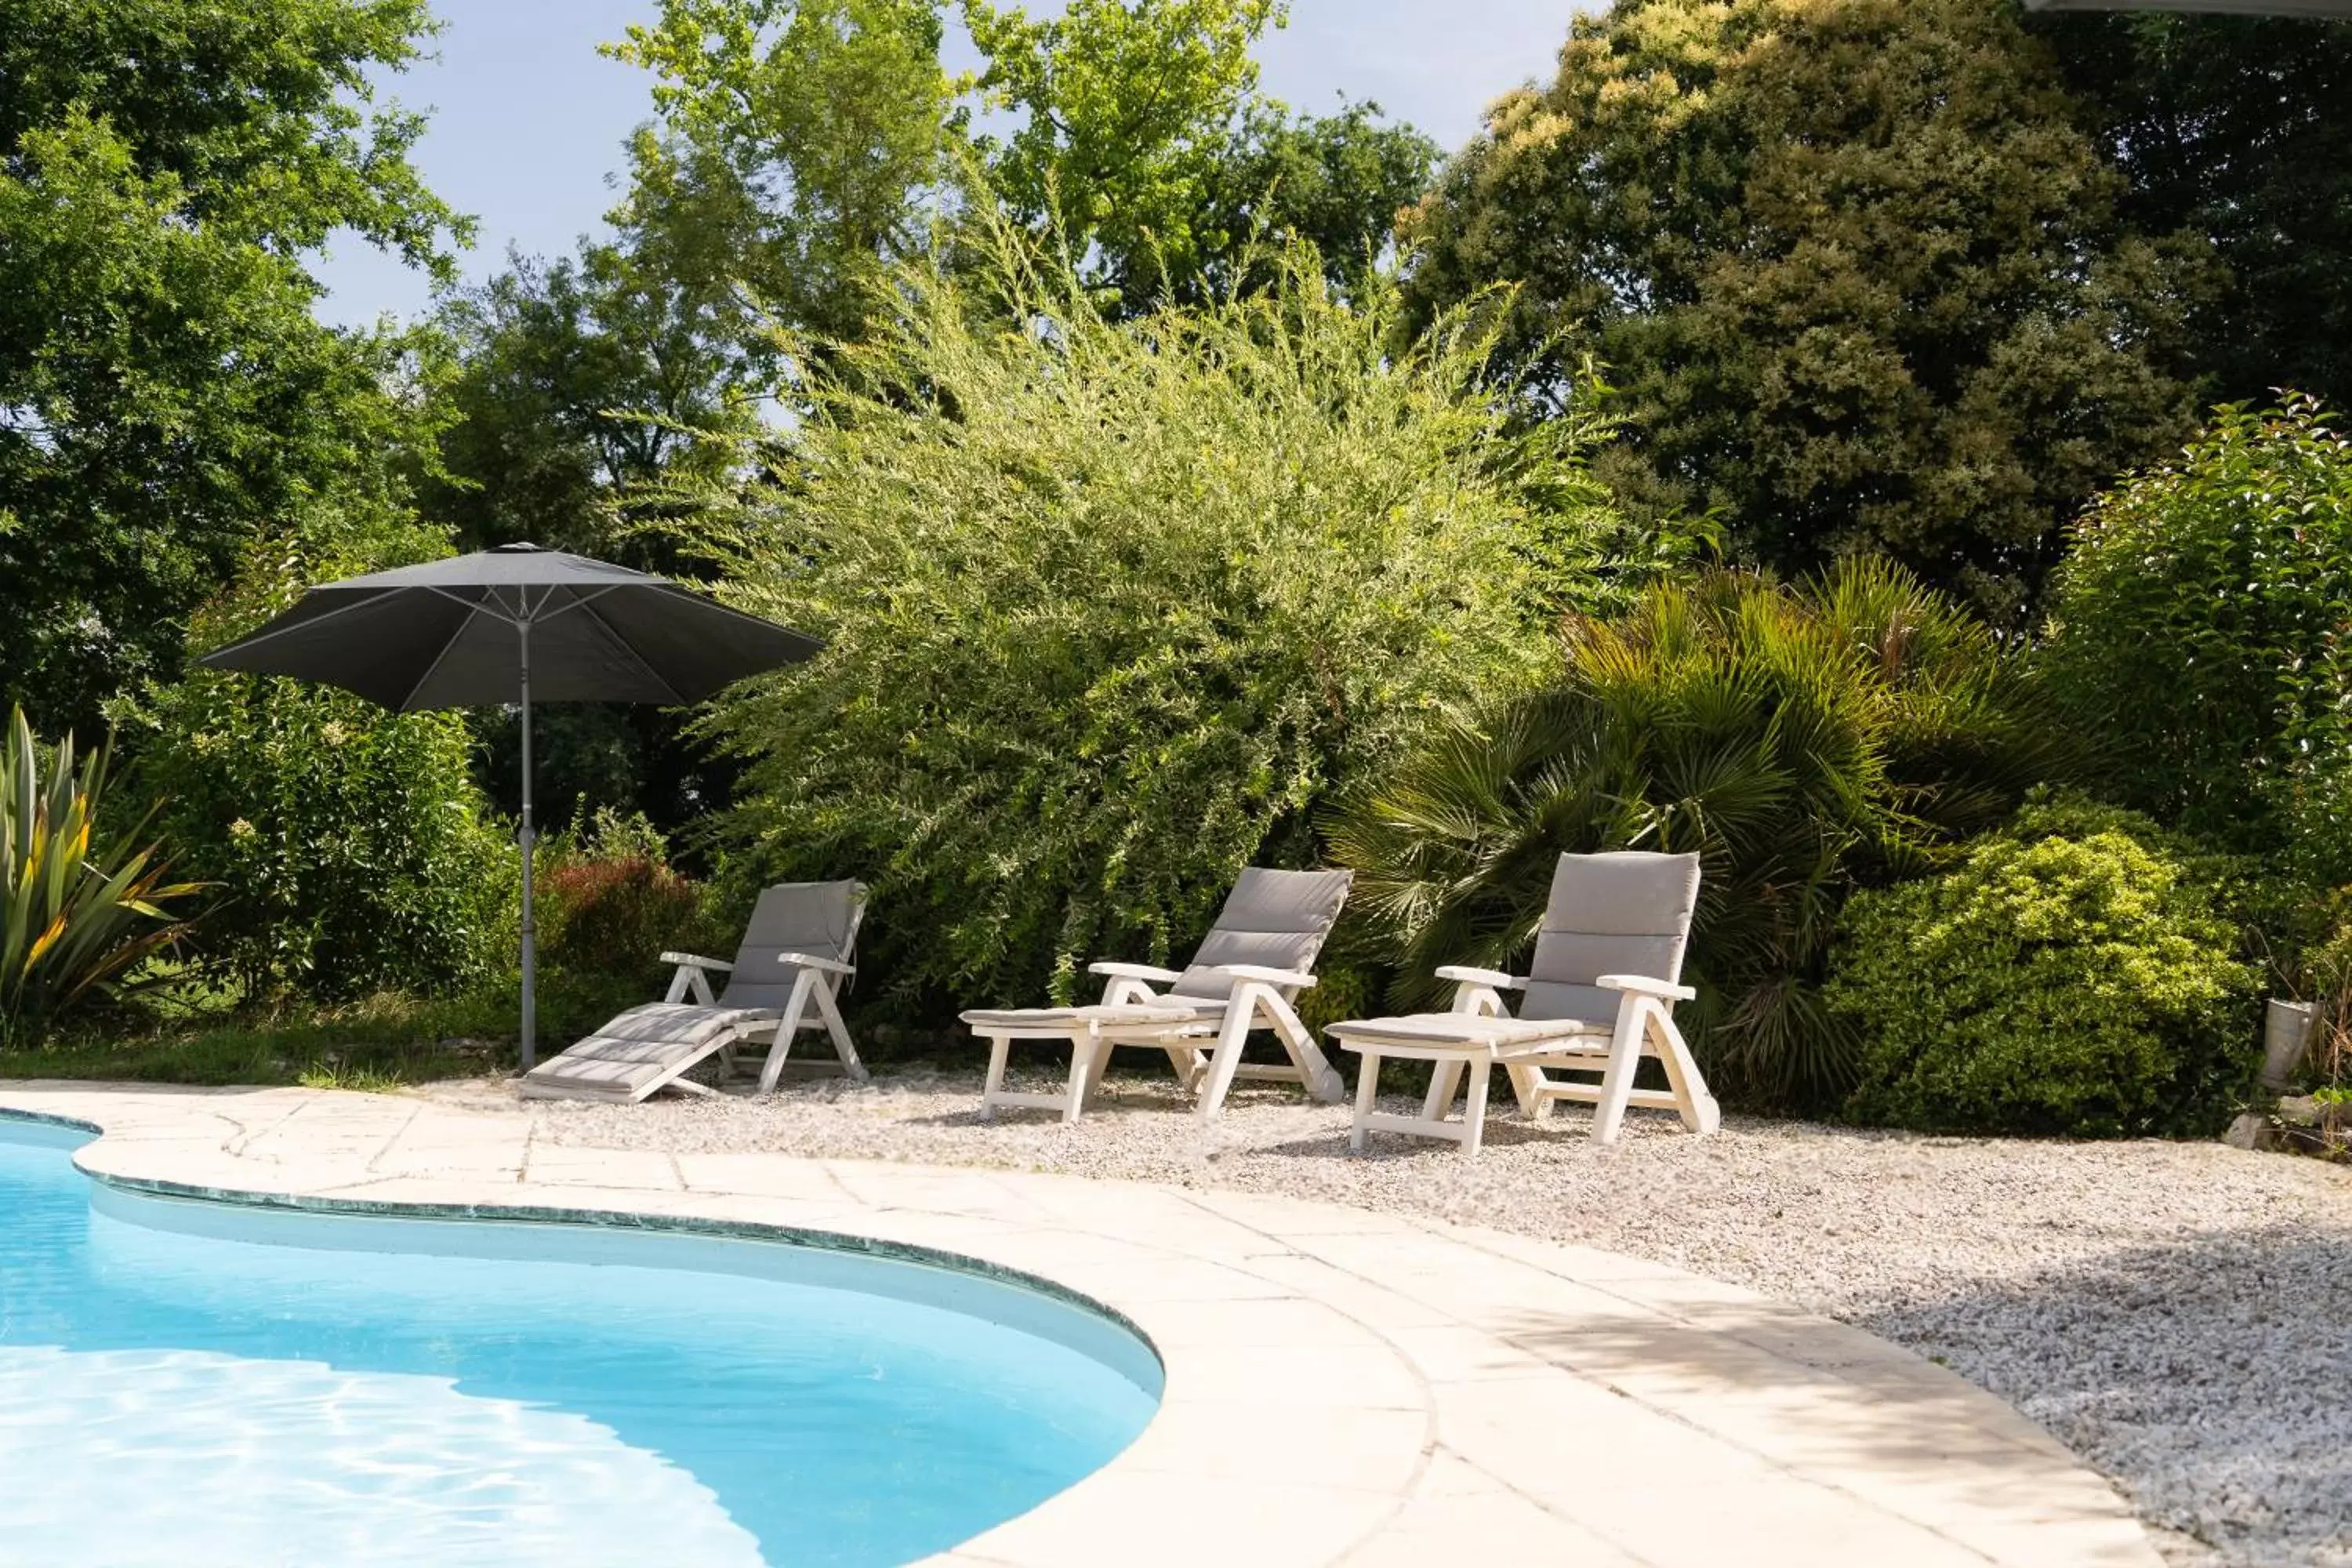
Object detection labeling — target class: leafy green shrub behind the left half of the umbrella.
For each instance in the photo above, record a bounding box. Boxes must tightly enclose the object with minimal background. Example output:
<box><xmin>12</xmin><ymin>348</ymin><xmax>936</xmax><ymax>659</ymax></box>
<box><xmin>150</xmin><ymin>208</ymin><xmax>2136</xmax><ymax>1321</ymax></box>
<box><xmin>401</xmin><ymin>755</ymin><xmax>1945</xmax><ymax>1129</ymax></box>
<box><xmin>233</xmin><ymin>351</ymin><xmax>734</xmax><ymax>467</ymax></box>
<box><xmin>134</xmin><ymin>515</ymin><xmax>517</xmax><ymax>999</ymax></box>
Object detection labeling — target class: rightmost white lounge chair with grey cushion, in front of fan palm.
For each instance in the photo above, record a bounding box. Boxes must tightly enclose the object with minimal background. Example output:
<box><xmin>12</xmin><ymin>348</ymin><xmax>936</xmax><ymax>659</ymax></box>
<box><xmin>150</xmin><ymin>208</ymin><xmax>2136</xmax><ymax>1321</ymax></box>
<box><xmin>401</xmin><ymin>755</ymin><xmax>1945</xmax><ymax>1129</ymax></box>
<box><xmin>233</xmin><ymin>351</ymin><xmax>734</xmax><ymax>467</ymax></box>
<box><xmin>1331</xmin><ymin>851</ymin><xmax>1722</xmax><ymax>1154</ymax></box>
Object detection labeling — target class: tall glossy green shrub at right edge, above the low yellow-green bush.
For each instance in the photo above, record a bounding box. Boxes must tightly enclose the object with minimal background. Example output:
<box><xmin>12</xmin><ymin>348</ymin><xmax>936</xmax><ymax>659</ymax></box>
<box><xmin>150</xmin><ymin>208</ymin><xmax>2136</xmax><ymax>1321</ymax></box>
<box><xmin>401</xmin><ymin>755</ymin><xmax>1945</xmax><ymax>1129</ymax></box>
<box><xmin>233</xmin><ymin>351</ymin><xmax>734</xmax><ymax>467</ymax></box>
<box><xmin>2046</xmin><ymin>397</ymin><xmax>2352</xmax><ymax>881</ymax></box>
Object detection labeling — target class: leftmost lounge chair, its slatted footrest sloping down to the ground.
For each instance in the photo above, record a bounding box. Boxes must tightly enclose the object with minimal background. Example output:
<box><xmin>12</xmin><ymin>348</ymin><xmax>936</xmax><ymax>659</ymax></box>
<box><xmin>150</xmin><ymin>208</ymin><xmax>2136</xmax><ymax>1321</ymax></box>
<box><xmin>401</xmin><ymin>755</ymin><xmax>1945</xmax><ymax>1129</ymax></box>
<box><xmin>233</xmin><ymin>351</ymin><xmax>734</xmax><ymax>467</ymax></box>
<box><xmin>522</xmin><ymin>881</ymin><xmax>866</xmax><ymax>1102</ymax></box>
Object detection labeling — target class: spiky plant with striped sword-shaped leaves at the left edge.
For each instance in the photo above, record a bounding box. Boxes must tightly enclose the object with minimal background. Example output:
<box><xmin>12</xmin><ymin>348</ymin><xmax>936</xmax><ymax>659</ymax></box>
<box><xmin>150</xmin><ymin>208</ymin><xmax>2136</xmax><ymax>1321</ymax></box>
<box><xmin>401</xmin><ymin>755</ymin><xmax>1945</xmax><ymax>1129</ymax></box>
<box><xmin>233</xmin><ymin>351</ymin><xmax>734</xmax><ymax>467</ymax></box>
<box><xmin>0</xmin><ymin>708</ymin><xmax>198</xmax><ymax>1041</ymax></box>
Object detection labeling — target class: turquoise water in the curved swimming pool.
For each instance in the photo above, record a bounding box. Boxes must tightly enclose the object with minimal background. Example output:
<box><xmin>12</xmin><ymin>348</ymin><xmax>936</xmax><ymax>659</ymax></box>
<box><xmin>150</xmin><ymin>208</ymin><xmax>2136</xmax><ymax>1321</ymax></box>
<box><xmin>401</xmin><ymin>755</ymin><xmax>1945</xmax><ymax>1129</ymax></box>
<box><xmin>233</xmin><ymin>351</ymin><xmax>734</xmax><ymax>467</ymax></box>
<box><xmin>0</xmin><ymin>1119</ymin><xmax>1160</xmax><ymax>1568</ymax></box>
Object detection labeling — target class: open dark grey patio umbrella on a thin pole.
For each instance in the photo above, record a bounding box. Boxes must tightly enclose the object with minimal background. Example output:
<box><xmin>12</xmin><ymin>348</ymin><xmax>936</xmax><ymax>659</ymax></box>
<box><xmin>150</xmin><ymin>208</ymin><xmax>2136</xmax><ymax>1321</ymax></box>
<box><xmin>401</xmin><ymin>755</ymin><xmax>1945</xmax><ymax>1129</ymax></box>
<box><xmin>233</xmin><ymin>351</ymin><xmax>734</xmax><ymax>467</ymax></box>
<box><xmin>198</xmin><ymin>546</ymin><xmax>823</xmax><ymax>1072</ymax></box>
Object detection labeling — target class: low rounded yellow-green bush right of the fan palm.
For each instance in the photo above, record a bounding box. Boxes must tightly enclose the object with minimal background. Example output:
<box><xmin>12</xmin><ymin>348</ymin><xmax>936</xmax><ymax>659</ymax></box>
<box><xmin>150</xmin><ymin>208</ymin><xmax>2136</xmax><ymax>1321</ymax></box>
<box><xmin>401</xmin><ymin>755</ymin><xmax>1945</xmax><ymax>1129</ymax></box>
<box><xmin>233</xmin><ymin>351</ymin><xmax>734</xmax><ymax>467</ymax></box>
<box><xmin>1825</xmin><ymin>804</ymin><xmax>2258</xmax><ymax>1135</ymax></box>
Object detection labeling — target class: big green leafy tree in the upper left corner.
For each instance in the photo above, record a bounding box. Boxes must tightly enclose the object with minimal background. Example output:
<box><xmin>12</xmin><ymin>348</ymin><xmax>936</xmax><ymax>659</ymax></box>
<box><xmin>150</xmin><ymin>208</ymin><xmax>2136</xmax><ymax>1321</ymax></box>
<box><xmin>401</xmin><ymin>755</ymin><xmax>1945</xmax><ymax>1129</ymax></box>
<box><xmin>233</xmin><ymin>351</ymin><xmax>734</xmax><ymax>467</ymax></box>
<box><xmin>0</xmin><ymin>0</ymin><xmax>463</xmax><ymax>729</ymax></box>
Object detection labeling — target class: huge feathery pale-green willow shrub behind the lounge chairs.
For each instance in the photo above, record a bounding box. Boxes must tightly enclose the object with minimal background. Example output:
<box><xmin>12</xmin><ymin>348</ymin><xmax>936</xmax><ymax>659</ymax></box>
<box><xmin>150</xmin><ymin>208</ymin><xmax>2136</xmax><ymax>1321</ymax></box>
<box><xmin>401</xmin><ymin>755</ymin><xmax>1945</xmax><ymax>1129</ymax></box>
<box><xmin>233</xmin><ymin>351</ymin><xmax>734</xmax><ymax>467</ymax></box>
<box><xmin>696</xmin><ymin>230</ymin><xmax>1672</xmax><ymax>1006</ymax></box>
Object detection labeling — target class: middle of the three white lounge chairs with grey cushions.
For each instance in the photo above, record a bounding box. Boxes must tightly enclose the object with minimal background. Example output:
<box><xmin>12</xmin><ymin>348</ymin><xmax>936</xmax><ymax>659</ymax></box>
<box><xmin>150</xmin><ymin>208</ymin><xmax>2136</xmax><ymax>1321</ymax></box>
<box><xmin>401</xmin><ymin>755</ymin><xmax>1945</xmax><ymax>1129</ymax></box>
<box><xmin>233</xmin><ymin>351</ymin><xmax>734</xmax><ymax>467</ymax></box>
<box><xmin>964</xmin><ymin>865</ymin><xmax>1350</xmax><ymax>1121</ymax></box>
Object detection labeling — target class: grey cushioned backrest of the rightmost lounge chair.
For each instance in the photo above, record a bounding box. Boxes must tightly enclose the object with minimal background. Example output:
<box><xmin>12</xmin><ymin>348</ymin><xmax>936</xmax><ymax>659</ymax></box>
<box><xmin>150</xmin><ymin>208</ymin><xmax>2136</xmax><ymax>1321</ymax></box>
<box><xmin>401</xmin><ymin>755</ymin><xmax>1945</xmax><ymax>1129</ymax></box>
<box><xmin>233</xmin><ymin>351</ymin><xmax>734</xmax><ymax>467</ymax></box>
<box><xmin>1519</xmin><ymin>848</ymin><xmax>1698</xmax><ymax>1022</ymax></box>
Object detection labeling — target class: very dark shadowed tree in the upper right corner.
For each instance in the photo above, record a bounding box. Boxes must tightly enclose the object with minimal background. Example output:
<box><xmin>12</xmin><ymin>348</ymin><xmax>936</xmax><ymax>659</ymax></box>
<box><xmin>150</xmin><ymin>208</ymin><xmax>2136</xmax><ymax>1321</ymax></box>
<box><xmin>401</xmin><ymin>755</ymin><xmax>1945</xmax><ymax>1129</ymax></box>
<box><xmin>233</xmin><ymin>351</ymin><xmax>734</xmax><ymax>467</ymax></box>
<box><xmin>2030</xmin><ymin>14</ymin><xmax>2352</xmax><ymax>420</ymax></box>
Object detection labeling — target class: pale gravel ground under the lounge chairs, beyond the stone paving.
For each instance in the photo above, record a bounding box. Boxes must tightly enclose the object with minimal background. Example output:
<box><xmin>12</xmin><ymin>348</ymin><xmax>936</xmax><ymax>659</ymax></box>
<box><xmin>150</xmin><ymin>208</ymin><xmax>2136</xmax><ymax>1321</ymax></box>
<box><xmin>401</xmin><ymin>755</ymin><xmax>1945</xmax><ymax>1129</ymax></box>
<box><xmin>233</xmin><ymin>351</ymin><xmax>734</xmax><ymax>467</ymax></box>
<box><xmin>428</xmin><ymin>1072</ymin><xmax>2352</xmax><ymax>1568</ymax></box>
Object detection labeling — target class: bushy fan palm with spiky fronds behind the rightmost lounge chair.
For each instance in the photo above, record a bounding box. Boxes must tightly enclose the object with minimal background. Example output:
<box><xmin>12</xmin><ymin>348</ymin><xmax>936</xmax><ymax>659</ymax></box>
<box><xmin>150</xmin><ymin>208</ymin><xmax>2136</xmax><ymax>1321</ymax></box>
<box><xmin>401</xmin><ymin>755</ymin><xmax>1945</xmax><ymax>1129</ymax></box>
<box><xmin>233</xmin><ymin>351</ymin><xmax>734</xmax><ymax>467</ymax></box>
<box><xmin>1331</xmin><ymin>560</ymin><xmax>2072</xmax><ymax>1107</ymax></box>
